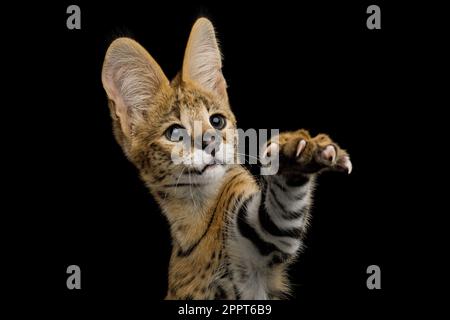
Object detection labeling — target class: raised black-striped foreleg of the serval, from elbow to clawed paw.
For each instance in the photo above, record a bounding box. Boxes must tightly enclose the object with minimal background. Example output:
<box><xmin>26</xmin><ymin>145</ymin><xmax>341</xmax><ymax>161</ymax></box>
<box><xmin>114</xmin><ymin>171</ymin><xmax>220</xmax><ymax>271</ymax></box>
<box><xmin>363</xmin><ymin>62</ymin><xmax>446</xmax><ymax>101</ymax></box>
<box><xmin>255</xmin><ymin>130</ymin><xmax>352</xmax><ymax>255</ymax></box>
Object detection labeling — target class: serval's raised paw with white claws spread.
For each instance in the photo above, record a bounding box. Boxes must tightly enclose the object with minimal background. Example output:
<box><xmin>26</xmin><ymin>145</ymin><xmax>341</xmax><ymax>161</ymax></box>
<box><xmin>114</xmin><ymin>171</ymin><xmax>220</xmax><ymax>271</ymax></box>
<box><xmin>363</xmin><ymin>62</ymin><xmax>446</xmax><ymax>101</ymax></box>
<box><xmin>265</xmin><ymin>130</ymin><xmax>352</xmax><ymax>174</ymax></box>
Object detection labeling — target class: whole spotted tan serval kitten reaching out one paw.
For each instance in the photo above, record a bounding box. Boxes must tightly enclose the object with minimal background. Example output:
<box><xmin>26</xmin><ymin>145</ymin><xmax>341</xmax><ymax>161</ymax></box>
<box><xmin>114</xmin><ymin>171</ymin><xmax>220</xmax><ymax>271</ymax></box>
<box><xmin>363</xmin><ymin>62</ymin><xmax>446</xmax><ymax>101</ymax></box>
<box><xmin>102</xmin><ymin>18</ymin><xmax>351</xmax><ymax>299</ymax></box>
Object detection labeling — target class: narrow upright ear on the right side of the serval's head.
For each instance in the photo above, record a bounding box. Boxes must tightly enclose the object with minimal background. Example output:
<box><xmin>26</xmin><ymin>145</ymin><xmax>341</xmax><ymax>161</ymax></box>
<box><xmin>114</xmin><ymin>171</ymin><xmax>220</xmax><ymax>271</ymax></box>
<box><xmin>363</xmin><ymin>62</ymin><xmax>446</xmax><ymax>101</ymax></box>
<box><xmin>182</xmin><ymin>18</ymin><xmax>227</xmax><ymax>99</ymax></box>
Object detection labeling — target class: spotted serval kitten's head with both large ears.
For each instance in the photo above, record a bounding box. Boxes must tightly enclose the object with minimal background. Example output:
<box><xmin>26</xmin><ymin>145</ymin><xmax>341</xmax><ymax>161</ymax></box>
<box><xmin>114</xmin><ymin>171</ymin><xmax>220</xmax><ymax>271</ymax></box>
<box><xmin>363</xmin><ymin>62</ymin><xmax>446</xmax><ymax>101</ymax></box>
<box><xmin>102</xmin><ymin>18</ymin><xmax>236</xmax><ymax>196</ymax></box>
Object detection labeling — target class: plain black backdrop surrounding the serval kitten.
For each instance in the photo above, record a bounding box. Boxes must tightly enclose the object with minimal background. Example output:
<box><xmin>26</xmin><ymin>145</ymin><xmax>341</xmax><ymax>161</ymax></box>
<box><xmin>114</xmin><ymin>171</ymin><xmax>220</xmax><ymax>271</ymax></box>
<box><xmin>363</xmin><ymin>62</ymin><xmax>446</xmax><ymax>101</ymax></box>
<box><xmin>3</xmin><ymin>1</ymin><xmax>444</xmax><ymax>317</ymax></box>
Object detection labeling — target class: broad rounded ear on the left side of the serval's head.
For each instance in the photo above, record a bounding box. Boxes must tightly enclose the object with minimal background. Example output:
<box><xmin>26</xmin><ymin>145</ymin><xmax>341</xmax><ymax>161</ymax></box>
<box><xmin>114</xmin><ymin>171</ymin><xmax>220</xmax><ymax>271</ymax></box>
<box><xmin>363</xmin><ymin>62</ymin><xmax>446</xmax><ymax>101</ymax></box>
<box><xmin>102</xmin><ymin>38</ymin><xmax>169</xmax><ymax>137</ymax></box>
